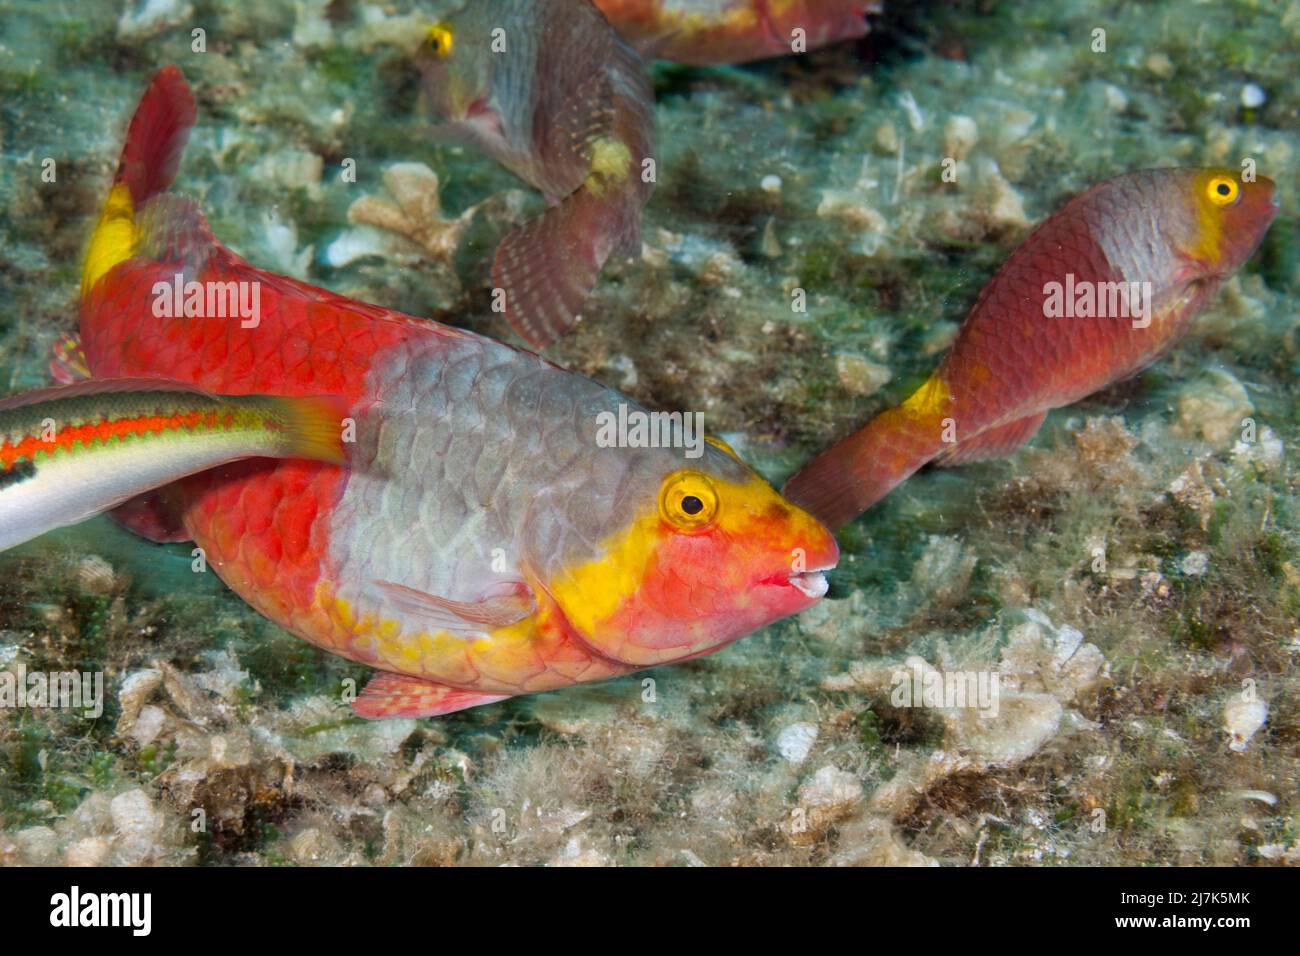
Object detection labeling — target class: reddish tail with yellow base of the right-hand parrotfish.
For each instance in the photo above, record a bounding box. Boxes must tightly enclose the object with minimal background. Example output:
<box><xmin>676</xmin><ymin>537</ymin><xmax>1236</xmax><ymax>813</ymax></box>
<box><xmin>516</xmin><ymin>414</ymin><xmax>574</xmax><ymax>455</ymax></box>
<box><xmin>781</xmin><ymin>372</ymin><xmax>952</xmax><ymax>531</ymax></box>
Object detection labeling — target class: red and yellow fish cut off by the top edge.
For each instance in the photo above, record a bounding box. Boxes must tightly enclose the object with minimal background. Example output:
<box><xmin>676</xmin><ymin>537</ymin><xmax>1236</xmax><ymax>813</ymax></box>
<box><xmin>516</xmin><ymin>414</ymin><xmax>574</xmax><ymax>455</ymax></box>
<box><xmin>595</xmin><ymin>0</ymin><xmax>880</xmax><ymax>66</ymax></box>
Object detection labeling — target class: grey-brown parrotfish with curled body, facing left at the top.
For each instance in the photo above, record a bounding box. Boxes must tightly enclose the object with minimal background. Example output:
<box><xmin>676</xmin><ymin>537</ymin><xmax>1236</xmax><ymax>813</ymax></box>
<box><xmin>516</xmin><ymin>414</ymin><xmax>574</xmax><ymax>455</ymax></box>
<box><xmin>419</xmin><ymin>0</ymin><xmax>657</xmax><ymax>349</ymax></box>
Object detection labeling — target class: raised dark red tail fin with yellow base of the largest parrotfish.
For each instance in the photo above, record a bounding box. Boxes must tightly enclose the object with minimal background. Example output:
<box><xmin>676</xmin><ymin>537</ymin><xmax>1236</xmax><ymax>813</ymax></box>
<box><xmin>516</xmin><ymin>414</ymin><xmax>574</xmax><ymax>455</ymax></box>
<box><xmin>82</xmin><ymin>66</ymin><xmax>196</xmax><ymax>297</ymax></box>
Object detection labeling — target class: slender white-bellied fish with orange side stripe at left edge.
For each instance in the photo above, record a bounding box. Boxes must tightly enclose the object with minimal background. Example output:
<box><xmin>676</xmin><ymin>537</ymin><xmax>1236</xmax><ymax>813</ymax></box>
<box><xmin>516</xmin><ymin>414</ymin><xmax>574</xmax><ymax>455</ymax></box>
<box><xmin>0</xmin><ymin>378</ymin><xmax>345</xmax><ymax>550</ymax></box>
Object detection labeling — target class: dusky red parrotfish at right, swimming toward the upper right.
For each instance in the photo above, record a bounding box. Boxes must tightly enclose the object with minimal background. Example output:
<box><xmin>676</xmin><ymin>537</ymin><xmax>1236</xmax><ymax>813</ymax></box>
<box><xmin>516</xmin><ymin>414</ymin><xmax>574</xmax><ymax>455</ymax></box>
<box><xmin>784</xmin><ymin>169</ymin><xmax>1278</xmax><ymax>528</ymax></box>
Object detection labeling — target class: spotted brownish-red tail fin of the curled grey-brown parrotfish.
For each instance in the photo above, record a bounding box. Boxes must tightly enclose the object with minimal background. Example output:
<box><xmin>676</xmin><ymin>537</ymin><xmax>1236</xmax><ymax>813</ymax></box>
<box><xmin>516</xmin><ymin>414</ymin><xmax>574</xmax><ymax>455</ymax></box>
<box><xmin>493</xmin><ymin>183</ymin><xmax>641</xmax><ymax>349</ymax></box>
